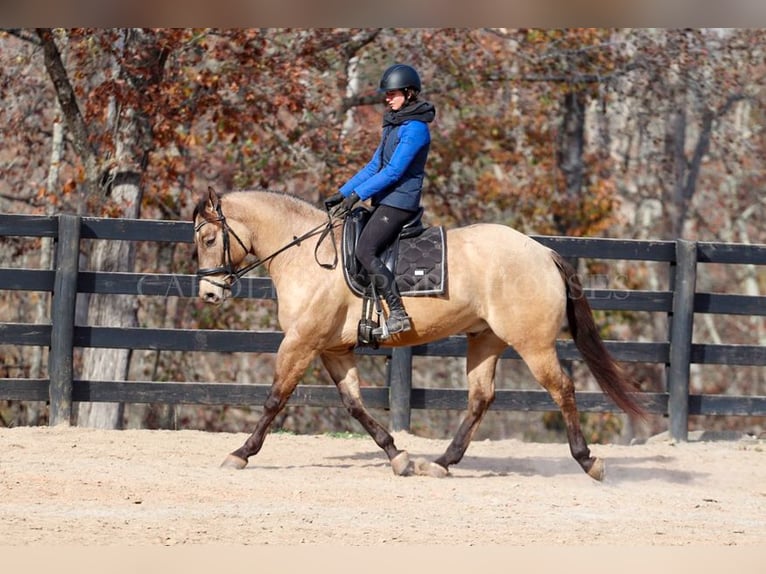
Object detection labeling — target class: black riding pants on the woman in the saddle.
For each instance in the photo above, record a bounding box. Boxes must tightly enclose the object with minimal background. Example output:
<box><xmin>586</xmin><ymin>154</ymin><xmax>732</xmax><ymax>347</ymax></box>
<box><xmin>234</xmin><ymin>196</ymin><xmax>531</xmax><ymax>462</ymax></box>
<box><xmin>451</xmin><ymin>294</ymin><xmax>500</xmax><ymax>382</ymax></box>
<box><xmin>356</xmin><ymin>205</ymin><xmax>413</xmax><ymax>293</ymax></box>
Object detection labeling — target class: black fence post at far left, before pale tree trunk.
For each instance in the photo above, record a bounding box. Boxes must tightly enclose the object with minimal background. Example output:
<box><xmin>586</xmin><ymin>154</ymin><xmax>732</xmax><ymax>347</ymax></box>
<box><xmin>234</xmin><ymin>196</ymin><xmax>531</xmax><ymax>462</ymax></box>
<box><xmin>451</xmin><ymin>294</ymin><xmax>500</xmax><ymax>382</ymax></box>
<box><xmin>48</xmin><ymin>215</ymin><xmax>80</xmax><ymax>426</ymax></box>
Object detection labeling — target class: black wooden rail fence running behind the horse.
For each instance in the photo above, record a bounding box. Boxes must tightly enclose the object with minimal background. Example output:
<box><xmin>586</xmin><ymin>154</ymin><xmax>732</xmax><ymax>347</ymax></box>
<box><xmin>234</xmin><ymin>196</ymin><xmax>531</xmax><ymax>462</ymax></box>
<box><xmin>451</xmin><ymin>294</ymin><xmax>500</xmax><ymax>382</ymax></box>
<box><xmin>0</xmin><ymin>214</ymin><xmax>766</xmax><ymax>440</ymax></box>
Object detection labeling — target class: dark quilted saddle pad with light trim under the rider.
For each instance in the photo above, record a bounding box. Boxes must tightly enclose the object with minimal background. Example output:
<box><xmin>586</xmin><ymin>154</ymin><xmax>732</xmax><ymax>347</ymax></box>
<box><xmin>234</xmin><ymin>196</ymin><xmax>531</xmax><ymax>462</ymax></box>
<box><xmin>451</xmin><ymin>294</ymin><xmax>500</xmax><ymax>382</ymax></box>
<box><xmin>343</xmin><ymin>226</ymin><xmax>447</xmax><ymax>297</ymax></box>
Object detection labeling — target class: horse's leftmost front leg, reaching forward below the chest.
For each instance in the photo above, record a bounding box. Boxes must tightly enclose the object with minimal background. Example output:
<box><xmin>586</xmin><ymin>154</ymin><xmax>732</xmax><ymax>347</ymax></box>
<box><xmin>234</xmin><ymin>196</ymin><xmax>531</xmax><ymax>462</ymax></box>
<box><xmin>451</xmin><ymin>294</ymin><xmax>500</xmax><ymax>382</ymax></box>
<box><xmin>221</xmin><ymin>333</ymin><xmax>316</xmax><ymax>469</ymax></box>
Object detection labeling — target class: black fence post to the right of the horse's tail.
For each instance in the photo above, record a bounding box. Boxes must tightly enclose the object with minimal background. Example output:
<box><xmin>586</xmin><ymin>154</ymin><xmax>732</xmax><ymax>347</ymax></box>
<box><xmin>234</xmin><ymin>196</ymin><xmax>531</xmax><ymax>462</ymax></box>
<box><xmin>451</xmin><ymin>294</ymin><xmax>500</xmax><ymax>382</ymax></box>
<box><xmin>668</xmin><ymin>239</ymin><xmax>697</xmax><ymax>441</ymax></box>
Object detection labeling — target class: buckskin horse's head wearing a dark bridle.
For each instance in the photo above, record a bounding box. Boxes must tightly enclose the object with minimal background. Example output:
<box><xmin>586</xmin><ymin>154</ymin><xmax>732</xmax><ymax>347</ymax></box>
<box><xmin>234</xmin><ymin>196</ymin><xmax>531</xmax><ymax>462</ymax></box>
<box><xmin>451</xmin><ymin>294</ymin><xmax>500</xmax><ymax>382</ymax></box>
<box><xmin>193</xmin><ymin>187</ymin><xmax>250</xmax><ymax>304</ymax></box>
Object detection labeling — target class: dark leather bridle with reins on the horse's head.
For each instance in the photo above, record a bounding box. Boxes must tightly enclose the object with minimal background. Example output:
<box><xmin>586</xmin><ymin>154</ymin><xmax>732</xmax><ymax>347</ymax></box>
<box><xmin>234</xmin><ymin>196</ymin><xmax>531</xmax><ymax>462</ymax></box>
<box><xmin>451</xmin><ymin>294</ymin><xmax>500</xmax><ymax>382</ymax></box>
<box><xmin>194</xmin><ymin>202</ymin><xmax>340</xmax><ymax>290</ymax></box>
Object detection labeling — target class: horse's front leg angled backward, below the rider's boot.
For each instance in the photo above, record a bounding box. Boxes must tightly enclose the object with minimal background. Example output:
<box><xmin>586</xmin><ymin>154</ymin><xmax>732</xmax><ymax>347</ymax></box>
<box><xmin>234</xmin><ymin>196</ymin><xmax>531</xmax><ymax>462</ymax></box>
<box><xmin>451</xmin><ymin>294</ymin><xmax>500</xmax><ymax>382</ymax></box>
<box><xmin>321</xmin><ymin>351</ymin><xmax>412</xmax><ymax>476</ymax></box>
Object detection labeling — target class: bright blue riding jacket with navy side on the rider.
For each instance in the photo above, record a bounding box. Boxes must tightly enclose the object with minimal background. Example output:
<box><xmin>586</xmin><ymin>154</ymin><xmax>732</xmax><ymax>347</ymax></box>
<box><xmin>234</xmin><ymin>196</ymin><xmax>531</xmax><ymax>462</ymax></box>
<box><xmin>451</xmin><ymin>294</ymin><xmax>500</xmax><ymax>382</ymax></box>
<box><xmin>340</xmin><ymin>103</ymin><xmax>433</xmax><ymax>211</ymax></box>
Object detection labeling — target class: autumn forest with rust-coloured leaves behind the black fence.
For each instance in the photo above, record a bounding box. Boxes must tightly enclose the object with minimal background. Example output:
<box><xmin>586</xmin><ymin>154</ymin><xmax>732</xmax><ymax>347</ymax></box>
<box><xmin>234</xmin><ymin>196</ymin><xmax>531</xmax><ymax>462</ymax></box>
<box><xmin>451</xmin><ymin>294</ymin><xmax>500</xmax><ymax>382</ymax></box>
<box><xmin>0</xmin><ymin>28</ymin><xmax>766</xmax><ymax>441</ymax></box>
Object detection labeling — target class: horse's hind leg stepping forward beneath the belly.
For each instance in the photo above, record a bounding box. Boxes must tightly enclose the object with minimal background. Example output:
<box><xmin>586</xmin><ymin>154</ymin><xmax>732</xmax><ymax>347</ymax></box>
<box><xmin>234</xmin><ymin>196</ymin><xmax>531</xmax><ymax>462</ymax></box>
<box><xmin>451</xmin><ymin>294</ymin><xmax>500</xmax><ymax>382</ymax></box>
<box><xmin>426</xmin><ymin>331</ymin><xmax>508</xmax><ymax>476</ymax></box>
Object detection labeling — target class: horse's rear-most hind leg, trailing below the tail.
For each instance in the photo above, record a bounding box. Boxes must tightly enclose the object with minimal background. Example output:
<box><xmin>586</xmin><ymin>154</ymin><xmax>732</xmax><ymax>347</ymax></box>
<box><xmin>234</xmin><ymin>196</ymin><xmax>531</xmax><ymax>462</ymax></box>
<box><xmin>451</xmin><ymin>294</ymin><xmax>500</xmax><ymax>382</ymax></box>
<box><xmin>520</xmin><ymin>349</ymin><xmax>604</xmax><ymax>480</ymax></box>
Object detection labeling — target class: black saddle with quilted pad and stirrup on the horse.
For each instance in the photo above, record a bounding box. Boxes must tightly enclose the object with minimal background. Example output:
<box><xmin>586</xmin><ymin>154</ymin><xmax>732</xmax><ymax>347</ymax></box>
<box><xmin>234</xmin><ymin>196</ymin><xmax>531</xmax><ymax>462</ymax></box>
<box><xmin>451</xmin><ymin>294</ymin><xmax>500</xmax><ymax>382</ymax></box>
<box><xmin>341</xmin><ymin>206</ymin><xmax>447</xmax><ymax>348</ymax></box>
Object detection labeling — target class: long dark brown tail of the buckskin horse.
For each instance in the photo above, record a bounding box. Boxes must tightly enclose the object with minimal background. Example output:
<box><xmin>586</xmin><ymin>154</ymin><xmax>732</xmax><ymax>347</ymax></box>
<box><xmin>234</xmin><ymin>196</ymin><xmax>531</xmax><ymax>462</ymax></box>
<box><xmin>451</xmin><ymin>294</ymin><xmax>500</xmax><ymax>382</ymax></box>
<box><xmin>553</xmin><ymin>252</ymin><xmax>646</xmax><ymax>417</ymax></box>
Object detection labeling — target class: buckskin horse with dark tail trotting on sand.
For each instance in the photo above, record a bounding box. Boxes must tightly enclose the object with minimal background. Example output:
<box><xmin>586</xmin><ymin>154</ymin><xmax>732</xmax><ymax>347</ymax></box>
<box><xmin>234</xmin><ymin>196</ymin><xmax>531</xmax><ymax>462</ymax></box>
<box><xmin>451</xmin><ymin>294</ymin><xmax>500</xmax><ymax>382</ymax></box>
<box><xmin>192</xmin><ymin>188</ymin><xmax>644</xmax><ymax>481</ymax></box>
